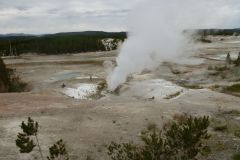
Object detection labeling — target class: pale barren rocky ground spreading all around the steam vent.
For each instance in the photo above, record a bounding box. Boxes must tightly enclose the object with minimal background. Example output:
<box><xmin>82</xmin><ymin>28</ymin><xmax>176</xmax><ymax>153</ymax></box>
<box><xmin>0</xmin><ymin>37</ymin><xmax>240</xmax><ymax>160</ymax></box>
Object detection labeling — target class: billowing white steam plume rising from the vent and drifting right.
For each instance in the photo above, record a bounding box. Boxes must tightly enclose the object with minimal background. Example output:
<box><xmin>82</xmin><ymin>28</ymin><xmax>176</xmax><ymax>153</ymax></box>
<box><xmin>107</xmin><ymin>0</ymin><xmax>240</xmax><ymax>90</ymax></box>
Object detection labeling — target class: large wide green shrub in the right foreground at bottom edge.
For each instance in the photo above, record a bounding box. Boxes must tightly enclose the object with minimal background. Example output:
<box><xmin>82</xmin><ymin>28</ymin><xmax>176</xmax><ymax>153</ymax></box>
<box><xmin>108</xmin><ymin>116</ymin><xmax>210</xmax><ymax>160</ymax></box>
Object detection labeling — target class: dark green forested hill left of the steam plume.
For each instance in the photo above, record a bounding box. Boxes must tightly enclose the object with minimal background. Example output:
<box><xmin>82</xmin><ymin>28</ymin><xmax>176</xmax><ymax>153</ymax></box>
<box><xmin>0</xmin><ymin>31</ymin><xmax>127</xmax><ymax>56</ymax></box>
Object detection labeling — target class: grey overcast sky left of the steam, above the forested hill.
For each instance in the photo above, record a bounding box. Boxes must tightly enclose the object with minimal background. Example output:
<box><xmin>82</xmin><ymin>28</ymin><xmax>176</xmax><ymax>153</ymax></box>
<box><xmin>0</xmin><ymin>0</ymin><xmax>141</xmax><ymax>34</ymax></box>
